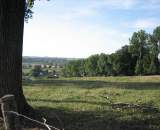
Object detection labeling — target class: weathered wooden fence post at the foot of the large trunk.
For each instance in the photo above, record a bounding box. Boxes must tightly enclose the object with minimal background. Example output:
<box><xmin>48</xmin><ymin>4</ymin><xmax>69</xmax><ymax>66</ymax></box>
<box><xmin>1</xmin><ymin>95</ymin><xmax>20</xmax><ymax>130</ymax></box>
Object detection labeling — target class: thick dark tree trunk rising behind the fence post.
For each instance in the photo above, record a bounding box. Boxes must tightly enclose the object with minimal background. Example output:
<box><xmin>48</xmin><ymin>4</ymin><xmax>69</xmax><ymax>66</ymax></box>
<box><xmin>0</xmin><ymin>0</ymin><xmax>30</xmax><ymax>114</ymax></box>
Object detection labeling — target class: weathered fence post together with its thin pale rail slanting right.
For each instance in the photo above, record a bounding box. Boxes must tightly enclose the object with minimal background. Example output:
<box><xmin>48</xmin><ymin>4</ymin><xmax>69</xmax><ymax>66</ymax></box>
<box><xmin>0</xmin><ymin>95</ymin><xmax>64</xmax><ymax>130</ymax></box>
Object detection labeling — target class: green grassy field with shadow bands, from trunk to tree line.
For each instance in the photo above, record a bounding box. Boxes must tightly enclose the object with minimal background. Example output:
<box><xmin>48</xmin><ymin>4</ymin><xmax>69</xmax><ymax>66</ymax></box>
<box><xmin>19</xmin><ymin>76</ymin><xmax>160</xmax><ymax>130</ymax></box>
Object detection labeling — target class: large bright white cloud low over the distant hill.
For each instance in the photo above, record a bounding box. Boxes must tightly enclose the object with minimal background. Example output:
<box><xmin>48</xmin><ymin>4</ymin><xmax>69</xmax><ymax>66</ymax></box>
<box><xmin>23</xmin><ymin>21</ymin><xmax>128</xmax><ymax>57</ymax></box>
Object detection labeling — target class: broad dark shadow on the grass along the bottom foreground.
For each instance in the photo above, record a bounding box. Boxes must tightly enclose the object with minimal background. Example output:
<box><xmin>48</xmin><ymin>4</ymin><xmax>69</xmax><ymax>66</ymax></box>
<box><xmin>34</xmin><ymin>107</ymin><xmax>160</xmax><ymax>130</ymax></box>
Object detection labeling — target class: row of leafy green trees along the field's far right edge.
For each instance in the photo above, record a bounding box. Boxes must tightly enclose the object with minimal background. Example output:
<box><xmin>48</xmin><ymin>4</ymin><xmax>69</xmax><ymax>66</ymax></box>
<box><xmin>62</xmin><ymin>26</ymin><xmax>160</xmax><ymax>77</ymax></box>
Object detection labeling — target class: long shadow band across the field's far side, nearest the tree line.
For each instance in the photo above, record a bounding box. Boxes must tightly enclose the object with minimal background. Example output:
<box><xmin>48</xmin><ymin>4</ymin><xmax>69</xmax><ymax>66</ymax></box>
<box><xmin>23</xmin><ymin>80</ymin><xmax>160</xmax><ymax>90</ymax></box>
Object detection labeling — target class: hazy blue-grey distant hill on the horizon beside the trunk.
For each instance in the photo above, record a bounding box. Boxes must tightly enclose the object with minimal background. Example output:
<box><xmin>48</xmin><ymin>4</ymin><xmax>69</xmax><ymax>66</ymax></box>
<box><xmin>23</xmin><ymin>56</ymin><xmax>75</xmax><ymax>65</ymax></box>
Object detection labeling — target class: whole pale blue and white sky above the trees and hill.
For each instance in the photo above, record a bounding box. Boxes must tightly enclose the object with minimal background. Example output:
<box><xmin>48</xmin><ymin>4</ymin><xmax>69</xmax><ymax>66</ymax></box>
<box><xmin>23</xmin><ymin>0</ymin><xmax>160</xmax><ymax>58</ymax></box>
